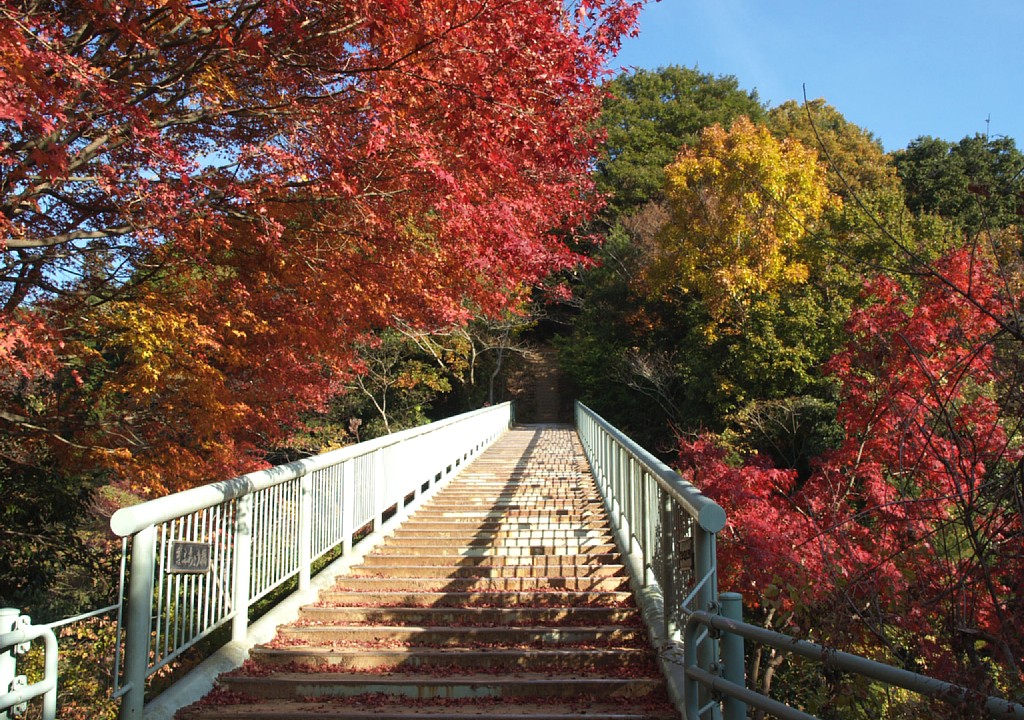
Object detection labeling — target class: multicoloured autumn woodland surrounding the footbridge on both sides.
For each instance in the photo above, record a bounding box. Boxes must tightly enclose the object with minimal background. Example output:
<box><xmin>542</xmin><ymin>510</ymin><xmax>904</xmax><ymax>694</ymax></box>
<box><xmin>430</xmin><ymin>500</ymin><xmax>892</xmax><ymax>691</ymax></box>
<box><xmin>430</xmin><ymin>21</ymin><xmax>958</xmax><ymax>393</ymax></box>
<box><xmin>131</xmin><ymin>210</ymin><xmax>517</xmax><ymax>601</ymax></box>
<box><xmin>0</xmin><ymin>0</ymin><xmax>1024</xmax><ymax>717</ymax></box>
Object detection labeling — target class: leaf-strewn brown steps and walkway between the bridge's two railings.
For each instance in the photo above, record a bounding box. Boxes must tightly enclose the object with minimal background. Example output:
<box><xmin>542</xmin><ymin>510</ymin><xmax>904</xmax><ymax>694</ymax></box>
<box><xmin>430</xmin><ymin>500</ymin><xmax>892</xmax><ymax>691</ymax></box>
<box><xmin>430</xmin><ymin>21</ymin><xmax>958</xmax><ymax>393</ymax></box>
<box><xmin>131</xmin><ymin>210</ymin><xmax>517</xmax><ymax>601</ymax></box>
<box><xmin>177</xmin><ymin>426</ymin><xmax>679</xmax><ymax>720</ymax></box>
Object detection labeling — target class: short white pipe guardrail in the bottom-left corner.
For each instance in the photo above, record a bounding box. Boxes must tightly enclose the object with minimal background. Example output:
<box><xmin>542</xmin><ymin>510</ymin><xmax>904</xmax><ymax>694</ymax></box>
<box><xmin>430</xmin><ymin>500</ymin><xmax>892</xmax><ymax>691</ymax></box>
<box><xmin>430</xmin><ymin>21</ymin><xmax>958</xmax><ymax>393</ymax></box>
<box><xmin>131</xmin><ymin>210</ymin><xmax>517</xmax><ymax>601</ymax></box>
<box><xmin>0</xmin><ymin>607</ymin><xmax>57</xmax><ymax>720</ymax></box>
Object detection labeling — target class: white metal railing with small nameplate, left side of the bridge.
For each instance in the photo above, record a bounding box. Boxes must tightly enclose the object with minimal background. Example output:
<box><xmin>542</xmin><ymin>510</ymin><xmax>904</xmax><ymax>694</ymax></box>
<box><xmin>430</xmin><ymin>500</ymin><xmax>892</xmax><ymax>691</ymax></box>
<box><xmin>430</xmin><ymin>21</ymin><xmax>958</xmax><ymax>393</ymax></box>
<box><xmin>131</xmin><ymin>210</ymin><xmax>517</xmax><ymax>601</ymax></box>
<box><xmin>111</xmin><ymin>403</ymin><xmax>511</xmax><ymax>718</ymax></box>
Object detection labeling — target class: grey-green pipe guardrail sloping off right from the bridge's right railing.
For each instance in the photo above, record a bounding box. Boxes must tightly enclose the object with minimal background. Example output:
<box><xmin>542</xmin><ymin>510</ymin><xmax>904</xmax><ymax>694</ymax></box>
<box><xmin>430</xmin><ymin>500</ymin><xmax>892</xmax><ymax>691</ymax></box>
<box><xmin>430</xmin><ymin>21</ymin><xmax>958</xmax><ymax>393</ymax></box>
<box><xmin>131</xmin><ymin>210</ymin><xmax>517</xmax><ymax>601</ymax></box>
<box><xmin>683</xmin><ymin>610</ymin><xmax>1024</xmax><ymax>720</ymax></box>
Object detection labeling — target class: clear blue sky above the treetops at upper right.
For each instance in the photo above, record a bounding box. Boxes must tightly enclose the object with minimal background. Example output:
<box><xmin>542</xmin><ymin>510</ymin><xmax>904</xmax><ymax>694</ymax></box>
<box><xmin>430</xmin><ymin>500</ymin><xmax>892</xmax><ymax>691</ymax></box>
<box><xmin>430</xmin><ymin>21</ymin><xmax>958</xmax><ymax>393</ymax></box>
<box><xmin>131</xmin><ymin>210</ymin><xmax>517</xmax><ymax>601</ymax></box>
<box><xmin>611</xmin><ymin>0</ymin><xmax>1024</xmax><ymax>151</ymax></box>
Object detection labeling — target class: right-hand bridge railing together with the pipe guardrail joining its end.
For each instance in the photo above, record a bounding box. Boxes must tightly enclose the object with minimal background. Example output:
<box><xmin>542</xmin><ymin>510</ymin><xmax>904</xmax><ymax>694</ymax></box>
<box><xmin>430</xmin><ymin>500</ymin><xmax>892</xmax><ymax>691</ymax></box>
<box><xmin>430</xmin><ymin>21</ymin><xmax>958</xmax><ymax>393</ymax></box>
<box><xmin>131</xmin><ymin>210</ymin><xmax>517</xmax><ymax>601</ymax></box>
<box><xmin>577</xmin><ymin>404</ymin><xmax>1024</xmax><ymax>720</ymax></box>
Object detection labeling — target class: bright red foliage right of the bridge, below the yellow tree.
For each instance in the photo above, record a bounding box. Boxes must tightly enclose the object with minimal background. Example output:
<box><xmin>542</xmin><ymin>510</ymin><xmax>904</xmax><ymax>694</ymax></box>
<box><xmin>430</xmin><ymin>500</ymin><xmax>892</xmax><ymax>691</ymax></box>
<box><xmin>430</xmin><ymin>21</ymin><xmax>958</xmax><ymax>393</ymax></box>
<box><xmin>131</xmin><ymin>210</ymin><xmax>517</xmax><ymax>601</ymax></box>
<box><xmin>680</xmin><ymin>250</ymin><xmax>1024</xmax><ymax>687</ymax></box>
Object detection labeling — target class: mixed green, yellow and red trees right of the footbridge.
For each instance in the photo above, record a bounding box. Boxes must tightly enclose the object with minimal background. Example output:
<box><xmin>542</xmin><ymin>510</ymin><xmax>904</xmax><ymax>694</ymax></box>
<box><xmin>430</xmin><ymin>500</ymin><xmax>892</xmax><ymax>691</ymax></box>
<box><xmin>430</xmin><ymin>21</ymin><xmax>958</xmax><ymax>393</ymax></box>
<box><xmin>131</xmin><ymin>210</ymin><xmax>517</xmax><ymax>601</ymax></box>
<box><xmin>560</xmin><ymin>68</ymin><xmax>1024</xmax><ymax>718</ymax></box>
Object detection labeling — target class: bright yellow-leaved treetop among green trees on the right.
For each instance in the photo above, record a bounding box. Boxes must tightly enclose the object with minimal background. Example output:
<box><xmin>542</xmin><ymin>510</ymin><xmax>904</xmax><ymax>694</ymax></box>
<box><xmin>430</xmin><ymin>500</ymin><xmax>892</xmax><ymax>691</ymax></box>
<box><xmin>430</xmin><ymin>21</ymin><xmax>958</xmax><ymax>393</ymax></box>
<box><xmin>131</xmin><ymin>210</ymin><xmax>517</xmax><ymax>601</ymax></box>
<box><xmin>649</xmin><ymin>118</ymin><xmax>840</xmax><ymax>325</ymax></box>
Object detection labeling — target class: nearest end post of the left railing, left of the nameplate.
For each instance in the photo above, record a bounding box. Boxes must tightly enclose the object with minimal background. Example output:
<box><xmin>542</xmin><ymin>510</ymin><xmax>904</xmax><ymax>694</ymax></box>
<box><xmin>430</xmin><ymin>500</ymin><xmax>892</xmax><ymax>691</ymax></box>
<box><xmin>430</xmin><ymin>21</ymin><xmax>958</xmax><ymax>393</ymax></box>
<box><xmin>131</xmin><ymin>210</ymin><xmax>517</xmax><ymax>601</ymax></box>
<box><xmin>121</xmin><ymin>525</ymin><xmax>157</xmax><ymax>720</ymax></box>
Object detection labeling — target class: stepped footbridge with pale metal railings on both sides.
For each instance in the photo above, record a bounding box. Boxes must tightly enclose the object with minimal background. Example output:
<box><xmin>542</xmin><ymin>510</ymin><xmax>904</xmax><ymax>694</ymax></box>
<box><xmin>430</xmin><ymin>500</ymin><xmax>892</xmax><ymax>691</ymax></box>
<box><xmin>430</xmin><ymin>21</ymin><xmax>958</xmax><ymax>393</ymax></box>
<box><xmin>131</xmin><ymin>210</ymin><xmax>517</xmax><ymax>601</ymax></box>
<box><xmin>0</xmin><ymin>404</ymin><xmax>1024</xmax><ymax>720</ymax></box>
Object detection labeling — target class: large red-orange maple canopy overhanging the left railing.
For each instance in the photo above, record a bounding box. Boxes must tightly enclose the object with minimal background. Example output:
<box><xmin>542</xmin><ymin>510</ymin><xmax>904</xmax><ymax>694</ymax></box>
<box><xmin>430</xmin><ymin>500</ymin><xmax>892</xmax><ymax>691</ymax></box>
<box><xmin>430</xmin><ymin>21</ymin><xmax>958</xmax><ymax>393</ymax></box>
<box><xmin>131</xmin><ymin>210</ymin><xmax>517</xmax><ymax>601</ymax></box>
<box><xmin>0</xmin><ymin>0</ymin><xmax>641</xmax><ymax>493</ymax></box>
